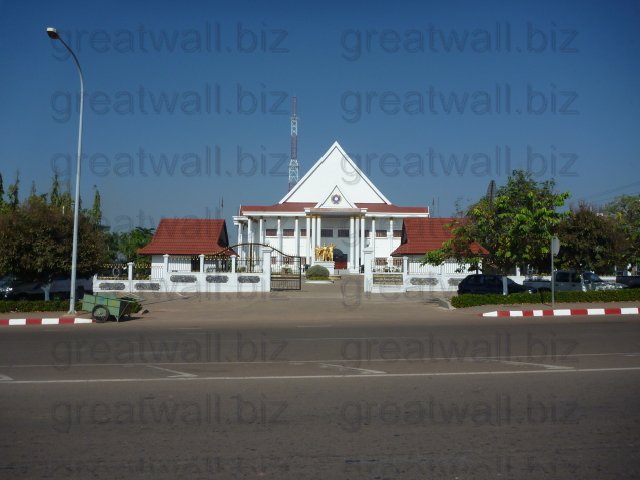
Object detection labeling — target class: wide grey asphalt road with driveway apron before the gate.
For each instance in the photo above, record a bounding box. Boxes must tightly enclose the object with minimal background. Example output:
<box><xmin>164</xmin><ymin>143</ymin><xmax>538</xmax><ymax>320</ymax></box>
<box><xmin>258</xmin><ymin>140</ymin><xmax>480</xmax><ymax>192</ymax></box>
<box><xmin>0</xmin><ymin>288</ymin><xmax>640</xmax><ymax>479</ymax></box>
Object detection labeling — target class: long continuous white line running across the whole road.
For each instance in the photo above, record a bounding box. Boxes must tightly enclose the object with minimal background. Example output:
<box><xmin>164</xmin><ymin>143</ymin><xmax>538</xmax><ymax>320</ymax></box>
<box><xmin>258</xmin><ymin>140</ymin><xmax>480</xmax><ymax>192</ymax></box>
<box><xmin>5</xmin><ymin>367</ymin><xmax>640</xmax><ymax>385</ymax></box>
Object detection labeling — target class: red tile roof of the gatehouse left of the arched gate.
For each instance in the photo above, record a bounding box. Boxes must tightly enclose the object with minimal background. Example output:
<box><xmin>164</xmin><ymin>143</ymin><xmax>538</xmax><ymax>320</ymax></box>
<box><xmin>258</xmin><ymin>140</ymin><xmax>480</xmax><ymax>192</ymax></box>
<box><xmin>138</xmin><ymin>218</ymin><xmax>229</xmax><ymax>255</ymax></box>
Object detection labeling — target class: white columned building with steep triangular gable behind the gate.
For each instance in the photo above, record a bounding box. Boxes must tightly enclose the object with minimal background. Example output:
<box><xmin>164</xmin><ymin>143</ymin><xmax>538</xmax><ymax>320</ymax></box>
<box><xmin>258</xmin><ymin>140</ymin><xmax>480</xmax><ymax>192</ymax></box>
<box><xmin>233</xmin><ymin>142</ymin><xmax>429</xmax><ymax>273</ymax></box>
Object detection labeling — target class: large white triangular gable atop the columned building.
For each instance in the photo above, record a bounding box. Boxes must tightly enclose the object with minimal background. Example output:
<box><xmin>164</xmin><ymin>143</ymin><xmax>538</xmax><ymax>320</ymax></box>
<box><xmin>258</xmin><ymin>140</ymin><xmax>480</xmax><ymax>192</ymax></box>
<box><xmin>278</xmin><ymin>142</ymin><xmax>391</xmax><ymax>205</ymax></box>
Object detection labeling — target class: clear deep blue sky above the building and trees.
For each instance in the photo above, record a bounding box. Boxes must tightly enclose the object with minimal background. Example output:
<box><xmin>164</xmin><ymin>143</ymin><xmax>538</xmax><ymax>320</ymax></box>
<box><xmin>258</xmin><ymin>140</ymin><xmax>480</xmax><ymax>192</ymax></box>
<box><xmin>0</xmin><ymin>0</ymin><xmax>640</xmax><ymax>232</ymax></box>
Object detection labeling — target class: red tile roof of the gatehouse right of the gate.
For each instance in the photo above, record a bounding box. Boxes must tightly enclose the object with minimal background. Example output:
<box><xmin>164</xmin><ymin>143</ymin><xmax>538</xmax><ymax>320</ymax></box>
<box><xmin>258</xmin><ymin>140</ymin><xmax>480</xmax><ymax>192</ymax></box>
<box><xmin>391</xmin><ymin>218</ymin><xmax>487</xmax><ymax>257</ymax></box>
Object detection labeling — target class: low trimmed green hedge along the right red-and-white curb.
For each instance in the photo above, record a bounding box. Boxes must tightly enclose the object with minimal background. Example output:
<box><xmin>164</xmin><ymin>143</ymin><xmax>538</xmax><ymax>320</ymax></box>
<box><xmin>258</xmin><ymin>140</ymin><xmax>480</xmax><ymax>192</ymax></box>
<box><xmin>451</xmin><ymin>288</ymin><xmax>640</xmax><ymax>308</ymax></box>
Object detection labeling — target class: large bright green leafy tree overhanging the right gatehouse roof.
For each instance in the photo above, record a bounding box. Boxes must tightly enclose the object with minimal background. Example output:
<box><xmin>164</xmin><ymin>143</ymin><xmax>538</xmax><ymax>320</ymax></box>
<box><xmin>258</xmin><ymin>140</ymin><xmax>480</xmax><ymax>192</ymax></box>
<box><xmin>423</xmin><ymin>170</ymin><xmax>569</xmax><ymax>273</ymax></box>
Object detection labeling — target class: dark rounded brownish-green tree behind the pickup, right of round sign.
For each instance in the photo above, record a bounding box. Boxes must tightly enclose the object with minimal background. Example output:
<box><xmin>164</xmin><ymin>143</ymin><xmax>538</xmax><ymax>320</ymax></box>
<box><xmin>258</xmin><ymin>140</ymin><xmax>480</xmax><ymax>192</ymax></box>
<box><xmin>558</xmin><ymin>203</ymin><xmax>628</xmax><ymax>273</ymax></box>
